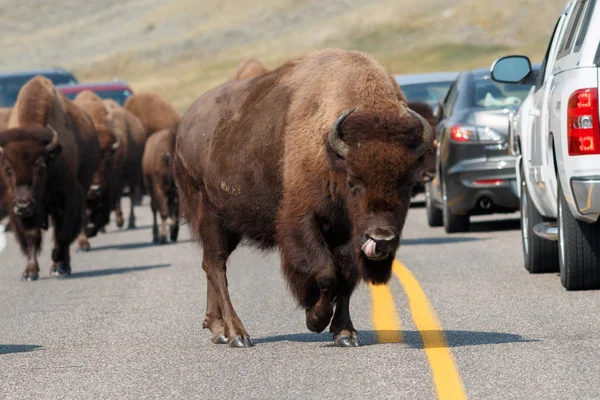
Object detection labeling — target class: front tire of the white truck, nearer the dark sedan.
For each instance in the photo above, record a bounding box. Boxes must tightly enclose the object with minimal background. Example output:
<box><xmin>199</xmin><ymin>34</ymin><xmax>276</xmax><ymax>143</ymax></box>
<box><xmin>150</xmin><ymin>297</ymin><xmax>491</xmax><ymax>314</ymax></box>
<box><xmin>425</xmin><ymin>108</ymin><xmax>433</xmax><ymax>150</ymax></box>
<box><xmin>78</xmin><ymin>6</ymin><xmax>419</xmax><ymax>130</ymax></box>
<box><xmin>521</xmin><ymin>167</ymin><xmax>559</xmax><ymax>274</ymax></box>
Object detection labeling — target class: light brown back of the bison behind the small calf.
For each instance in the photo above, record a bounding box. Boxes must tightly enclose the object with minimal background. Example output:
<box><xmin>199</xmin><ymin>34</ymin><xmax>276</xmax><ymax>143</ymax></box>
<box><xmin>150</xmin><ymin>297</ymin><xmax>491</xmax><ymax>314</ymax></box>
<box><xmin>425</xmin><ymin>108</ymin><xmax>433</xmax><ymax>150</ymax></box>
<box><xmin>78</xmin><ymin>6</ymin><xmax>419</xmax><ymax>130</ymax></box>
<box><xmin>124</xmin><ymin>93</ymin><xmax>181</xmax><ymax>136</ymax></box>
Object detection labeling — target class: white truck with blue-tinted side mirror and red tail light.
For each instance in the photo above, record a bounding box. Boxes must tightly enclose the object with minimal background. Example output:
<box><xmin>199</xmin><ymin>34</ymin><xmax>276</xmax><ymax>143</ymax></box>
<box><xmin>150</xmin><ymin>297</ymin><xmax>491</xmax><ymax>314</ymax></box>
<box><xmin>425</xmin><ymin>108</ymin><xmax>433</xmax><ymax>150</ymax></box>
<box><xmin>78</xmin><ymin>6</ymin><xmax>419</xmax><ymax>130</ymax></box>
<box><xmin>491</xmin><ymin>0</ymin><xmax>600</xmax><ymax>290</ymax></box>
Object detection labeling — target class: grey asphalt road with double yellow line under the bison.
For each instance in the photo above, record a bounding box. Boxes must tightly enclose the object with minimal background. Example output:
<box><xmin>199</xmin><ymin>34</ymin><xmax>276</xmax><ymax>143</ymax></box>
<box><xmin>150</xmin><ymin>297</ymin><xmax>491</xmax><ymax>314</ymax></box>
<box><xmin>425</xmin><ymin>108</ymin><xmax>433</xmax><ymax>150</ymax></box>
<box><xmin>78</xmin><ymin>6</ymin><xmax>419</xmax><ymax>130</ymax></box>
<box><xmin>0</xmin><ymin>199</ymin><xmax>600</xmax><ymax>399</ymax></box>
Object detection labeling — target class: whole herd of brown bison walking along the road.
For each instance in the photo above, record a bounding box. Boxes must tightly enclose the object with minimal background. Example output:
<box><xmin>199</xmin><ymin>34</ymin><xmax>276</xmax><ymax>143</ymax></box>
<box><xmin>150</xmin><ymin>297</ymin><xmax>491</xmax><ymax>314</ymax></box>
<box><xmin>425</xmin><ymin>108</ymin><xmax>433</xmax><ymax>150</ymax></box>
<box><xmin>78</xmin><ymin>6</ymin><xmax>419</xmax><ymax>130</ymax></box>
<box><xmin>0</xmin><ymin>49</ymin><xmax>434</xmax><ymax>347</ymax></box>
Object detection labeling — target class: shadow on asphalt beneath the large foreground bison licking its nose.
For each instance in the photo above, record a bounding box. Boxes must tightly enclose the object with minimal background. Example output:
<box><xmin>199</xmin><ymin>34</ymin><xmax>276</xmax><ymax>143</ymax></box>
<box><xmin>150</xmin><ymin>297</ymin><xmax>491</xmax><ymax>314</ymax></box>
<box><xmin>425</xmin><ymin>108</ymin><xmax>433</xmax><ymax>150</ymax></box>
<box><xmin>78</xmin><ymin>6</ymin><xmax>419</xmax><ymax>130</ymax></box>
<box><xmin>252</xmin><ymin>330</ymin><xmax>538</xmax><ymax>349</ymax></box>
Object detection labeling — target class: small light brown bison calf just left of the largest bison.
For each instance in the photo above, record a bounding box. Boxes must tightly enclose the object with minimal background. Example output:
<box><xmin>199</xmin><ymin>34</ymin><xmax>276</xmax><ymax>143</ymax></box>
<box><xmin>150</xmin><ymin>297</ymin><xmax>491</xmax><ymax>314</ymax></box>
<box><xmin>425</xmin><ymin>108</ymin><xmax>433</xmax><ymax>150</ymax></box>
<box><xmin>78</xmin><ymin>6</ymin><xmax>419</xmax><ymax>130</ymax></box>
<box><xmin>142</xmin><ymin>129</ymin><xmax>179</xmax><ymax>244</ymax></box>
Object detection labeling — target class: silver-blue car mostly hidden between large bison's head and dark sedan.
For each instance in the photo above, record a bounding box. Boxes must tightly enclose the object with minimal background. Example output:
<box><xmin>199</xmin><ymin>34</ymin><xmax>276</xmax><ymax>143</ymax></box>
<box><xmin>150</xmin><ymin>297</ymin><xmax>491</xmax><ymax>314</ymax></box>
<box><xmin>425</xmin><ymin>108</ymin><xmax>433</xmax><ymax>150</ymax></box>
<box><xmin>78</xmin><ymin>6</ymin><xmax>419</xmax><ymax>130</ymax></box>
<box><xmin>394</xmin><ymin>72</ymin><xmax>458</xmax><ymax>114</ymax></box>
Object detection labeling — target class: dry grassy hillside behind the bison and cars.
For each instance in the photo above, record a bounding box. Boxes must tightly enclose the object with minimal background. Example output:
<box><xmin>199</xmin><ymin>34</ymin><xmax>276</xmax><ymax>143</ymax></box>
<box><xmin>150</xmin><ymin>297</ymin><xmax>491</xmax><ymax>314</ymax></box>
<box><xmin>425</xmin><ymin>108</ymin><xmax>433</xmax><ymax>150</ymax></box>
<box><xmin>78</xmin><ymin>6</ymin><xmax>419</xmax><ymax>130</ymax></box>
<box><xmin>0</xmin><ymin>0</ymin><xmax>565</xmax><ymax>110</ymax></box>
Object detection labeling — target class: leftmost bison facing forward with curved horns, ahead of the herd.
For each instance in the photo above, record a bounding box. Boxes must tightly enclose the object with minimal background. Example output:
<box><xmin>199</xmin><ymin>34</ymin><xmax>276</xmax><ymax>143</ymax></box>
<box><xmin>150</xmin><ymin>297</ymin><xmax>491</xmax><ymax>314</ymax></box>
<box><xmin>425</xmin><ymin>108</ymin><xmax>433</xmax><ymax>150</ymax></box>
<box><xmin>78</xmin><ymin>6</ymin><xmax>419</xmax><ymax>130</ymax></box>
<box><xmin>0</xmin><ymin>76</ymin><xmax>100</xmax><ymax>280</ymax></box>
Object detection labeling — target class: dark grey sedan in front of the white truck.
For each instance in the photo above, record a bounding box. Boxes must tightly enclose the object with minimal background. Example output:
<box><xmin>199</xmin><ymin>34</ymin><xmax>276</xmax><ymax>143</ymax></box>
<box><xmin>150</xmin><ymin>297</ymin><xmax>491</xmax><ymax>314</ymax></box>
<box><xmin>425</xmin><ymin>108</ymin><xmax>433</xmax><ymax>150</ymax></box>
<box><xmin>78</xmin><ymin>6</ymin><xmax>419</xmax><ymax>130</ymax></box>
<box><xmin>425</xmin><ymin>65</ymin><xmax>539</xmax><ymax>233</ymax></box>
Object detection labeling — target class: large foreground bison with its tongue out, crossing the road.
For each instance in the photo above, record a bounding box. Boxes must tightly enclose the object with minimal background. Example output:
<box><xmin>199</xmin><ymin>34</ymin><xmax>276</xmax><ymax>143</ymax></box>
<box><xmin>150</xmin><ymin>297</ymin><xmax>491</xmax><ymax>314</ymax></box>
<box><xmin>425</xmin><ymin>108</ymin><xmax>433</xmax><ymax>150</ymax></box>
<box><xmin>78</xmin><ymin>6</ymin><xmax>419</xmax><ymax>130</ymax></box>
<box><xmin>174</xmin><ymin>50</ymin><xmax>432</xmax><ymax>347</ymax></box>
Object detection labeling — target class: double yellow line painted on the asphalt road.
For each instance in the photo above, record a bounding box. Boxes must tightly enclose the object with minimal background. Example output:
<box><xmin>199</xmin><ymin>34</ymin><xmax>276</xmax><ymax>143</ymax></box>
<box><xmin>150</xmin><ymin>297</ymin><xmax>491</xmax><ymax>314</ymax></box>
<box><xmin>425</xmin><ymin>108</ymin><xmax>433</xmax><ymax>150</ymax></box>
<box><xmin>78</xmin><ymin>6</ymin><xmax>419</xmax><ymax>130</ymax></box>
<box><xmin>370</xmin><ymin>261</ymin><xmax>466</xmax><ymax>400</ymax></box>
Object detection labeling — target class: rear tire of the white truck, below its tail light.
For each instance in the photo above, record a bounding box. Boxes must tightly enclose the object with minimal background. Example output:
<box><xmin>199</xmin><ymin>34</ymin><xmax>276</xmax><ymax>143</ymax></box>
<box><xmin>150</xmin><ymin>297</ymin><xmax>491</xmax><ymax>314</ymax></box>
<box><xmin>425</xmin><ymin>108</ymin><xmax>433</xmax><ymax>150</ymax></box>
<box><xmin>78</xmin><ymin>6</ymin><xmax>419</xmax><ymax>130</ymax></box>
<box><xmin>558</xmin><ymin>182</ymin><xmax>600</xmax><ymax>290</ymax></box>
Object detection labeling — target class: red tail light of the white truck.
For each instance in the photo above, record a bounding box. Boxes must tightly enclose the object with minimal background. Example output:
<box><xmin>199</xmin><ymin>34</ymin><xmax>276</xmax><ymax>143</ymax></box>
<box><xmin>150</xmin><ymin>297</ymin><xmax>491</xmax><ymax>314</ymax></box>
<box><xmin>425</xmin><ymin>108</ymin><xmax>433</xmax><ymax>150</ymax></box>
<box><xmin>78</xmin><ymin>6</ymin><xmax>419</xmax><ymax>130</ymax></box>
<box><xmin>567</xmin><ymin>88</ymin><xmax>600</xmax><ymax>156</ymax></box>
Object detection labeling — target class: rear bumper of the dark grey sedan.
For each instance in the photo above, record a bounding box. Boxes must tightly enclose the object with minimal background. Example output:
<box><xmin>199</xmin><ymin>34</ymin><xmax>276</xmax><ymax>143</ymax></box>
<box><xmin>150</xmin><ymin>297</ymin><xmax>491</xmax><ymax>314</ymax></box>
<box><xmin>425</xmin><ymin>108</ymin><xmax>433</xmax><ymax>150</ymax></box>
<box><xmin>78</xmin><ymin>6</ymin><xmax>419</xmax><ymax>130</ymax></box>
<box><xmin>446</xmin><ymin>157</ymin><xmax>520</xmax><ymax>215</ymax></box>
